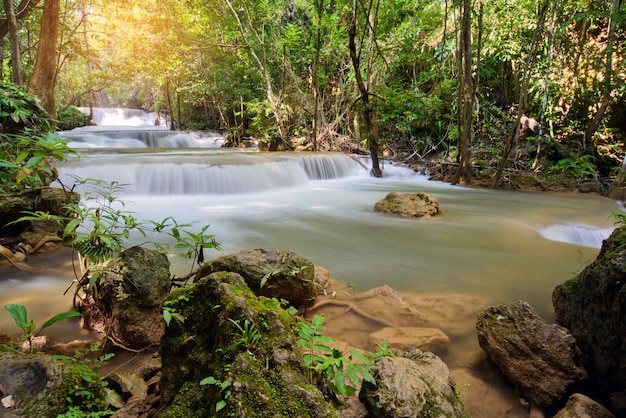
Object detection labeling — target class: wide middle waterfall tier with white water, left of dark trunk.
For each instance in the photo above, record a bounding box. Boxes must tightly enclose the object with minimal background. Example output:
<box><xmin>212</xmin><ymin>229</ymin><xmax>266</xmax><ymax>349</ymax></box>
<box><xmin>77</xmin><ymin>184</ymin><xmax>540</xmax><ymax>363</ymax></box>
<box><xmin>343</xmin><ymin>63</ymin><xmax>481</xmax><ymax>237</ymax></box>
<box><xmin>59</xmin><ymin>152</ymin><xmax>367</xmax><ymax>195</ymax></box>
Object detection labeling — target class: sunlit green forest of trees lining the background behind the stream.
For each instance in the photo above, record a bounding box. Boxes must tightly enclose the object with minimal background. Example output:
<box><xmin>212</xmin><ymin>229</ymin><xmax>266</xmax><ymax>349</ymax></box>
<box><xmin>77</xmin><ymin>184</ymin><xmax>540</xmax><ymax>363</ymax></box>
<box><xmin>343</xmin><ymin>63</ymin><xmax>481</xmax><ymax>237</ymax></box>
<box><xmin>0</xmin><ymin>0</ymin><xmax>626</xmax><ymax>185</ymax></box>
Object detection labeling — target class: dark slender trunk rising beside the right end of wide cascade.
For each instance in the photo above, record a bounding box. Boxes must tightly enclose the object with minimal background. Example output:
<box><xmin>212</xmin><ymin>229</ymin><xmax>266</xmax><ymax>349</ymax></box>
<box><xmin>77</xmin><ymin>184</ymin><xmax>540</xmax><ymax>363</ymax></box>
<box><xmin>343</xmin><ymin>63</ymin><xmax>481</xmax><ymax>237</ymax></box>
<box><xmin>347</xmin><ymin>0</ymin><xmax>383</xmax><ymax>177</ymax></box>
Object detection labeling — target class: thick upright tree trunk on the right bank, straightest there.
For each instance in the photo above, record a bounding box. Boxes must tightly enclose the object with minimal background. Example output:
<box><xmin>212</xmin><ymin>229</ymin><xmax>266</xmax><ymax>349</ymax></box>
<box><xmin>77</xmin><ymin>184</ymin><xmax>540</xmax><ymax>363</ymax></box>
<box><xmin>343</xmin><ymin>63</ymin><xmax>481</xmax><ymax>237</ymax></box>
<box><xmin>452</xmin><ymin>0</ymin><xmax>474</xmax><ymax>184</ymax></box>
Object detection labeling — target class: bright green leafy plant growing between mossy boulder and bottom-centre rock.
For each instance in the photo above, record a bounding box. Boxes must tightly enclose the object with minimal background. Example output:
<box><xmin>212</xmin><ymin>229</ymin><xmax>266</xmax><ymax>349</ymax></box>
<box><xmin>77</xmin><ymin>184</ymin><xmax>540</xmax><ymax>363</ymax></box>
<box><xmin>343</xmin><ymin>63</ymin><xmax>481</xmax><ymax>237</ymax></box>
<box><xmin>297</xmin><ymin>315</ymin><xmax>374</xmax><ymax>396</ymax></box>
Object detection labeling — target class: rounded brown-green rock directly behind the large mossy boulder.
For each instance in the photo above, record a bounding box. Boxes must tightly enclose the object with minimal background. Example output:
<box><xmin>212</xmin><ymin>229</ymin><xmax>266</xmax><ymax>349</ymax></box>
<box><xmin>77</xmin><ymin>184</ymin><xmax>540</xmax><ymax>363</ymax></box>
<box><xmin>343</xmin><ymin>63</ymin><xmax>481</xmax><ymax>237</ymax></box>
<box><xmin>195</xmin><ymin>248</ymin><xmax>319</xmax><ymax>307</ymax></box>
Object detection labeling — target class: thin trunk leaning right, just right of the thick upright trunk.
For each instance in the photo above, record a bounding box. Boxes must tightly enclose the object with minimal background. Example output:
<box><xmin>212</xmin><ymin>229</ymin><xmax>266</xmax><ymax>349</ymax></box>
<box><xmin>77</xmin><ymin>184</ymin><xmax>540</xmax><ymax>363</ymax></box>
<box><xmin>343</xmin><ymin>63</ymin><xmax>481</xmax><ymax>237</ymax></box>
<box><xmin>491</xmin><ymin>0</ymin><xmax>551</xmax><ymax>188</ymax></box>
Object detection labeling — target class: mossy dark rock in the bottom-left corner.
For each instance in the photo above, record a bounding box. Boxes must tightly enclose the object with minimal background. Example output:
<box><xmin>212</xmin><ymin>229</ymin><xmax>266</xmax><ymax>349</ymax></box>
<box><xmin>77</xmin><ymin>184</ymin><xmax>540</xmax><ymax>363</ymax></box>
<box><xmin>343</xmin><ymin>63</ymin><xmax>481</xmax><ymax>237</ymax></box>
<box><xmin>0</xmin><ymin>348</ymin><xmax>106</xmax><ymax>417</ymax></box>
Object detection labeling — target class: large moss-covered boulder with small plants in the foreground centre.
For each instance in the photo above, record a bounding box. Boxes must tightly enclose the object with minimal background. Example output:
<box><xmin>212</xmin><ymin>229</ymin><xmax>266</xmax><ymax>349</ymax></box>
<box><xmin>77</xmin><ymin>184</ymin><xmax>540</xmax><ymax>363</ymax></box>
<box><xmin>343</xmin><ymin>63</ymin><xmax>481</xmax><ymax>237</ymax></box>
<box><xmin>160</xmin><ymin>271</ymin><xmax>337</xmax><ymax>417</ymax></box>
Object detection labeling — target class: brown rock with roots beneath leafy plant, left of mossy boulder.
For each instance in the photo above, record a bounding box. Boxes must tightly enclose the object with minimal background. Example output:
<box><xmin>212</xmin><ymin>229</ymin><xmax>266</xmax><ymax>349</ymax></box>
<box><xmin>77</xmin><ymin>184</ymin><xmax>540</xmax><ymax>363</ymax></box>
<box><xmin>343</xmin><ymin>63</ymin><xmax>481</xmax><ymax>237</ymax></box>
<box><xmin>79</xmin><ymin>247</ymin><xmax>171</xmax><ymax>349</ymax></box>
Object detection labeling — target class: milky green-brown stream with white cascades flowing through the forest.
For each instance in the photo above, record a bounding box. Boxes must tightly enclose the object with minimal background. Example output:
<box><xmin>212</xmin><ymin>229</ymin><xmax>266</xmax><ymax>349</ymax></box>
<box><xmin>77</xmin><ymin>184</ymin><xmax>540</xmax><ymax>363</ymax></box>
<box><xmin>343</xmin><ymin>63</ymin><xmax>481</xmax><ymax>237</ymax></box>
<box><xmin>0</xmin><ymin>109</ymin><xmax>620</xmax><ymax>416</ymax></box>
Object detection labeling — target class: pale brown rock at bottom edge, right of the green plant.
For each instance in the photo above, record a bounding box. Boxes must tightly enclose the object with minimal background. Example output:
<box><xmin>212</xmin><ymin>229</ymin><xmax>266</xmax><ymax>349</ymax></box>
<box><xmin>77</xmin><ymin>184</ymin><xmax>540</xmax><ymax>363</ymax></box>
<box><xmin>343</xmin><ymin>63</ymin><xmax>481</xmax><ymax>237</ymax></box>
<box><xmin>359</xmin><ymin>349</ymin><xmax>468</xmax><ymax>418</ymax></box>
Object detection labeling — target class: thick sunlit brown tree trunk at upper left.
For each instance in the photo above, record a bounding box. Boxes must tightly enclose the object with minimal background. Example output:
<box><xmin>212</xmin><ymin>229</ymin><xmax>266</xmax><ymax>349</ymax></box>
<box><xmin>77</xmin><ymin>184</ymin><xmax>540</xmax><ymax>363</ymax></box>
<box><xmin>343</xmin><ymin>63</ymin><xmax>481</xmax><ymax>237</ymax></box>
<box><xmin>28</xmin><ymin>0</ymin><xmax>61</xmax><ymax>118</ymax></box>
